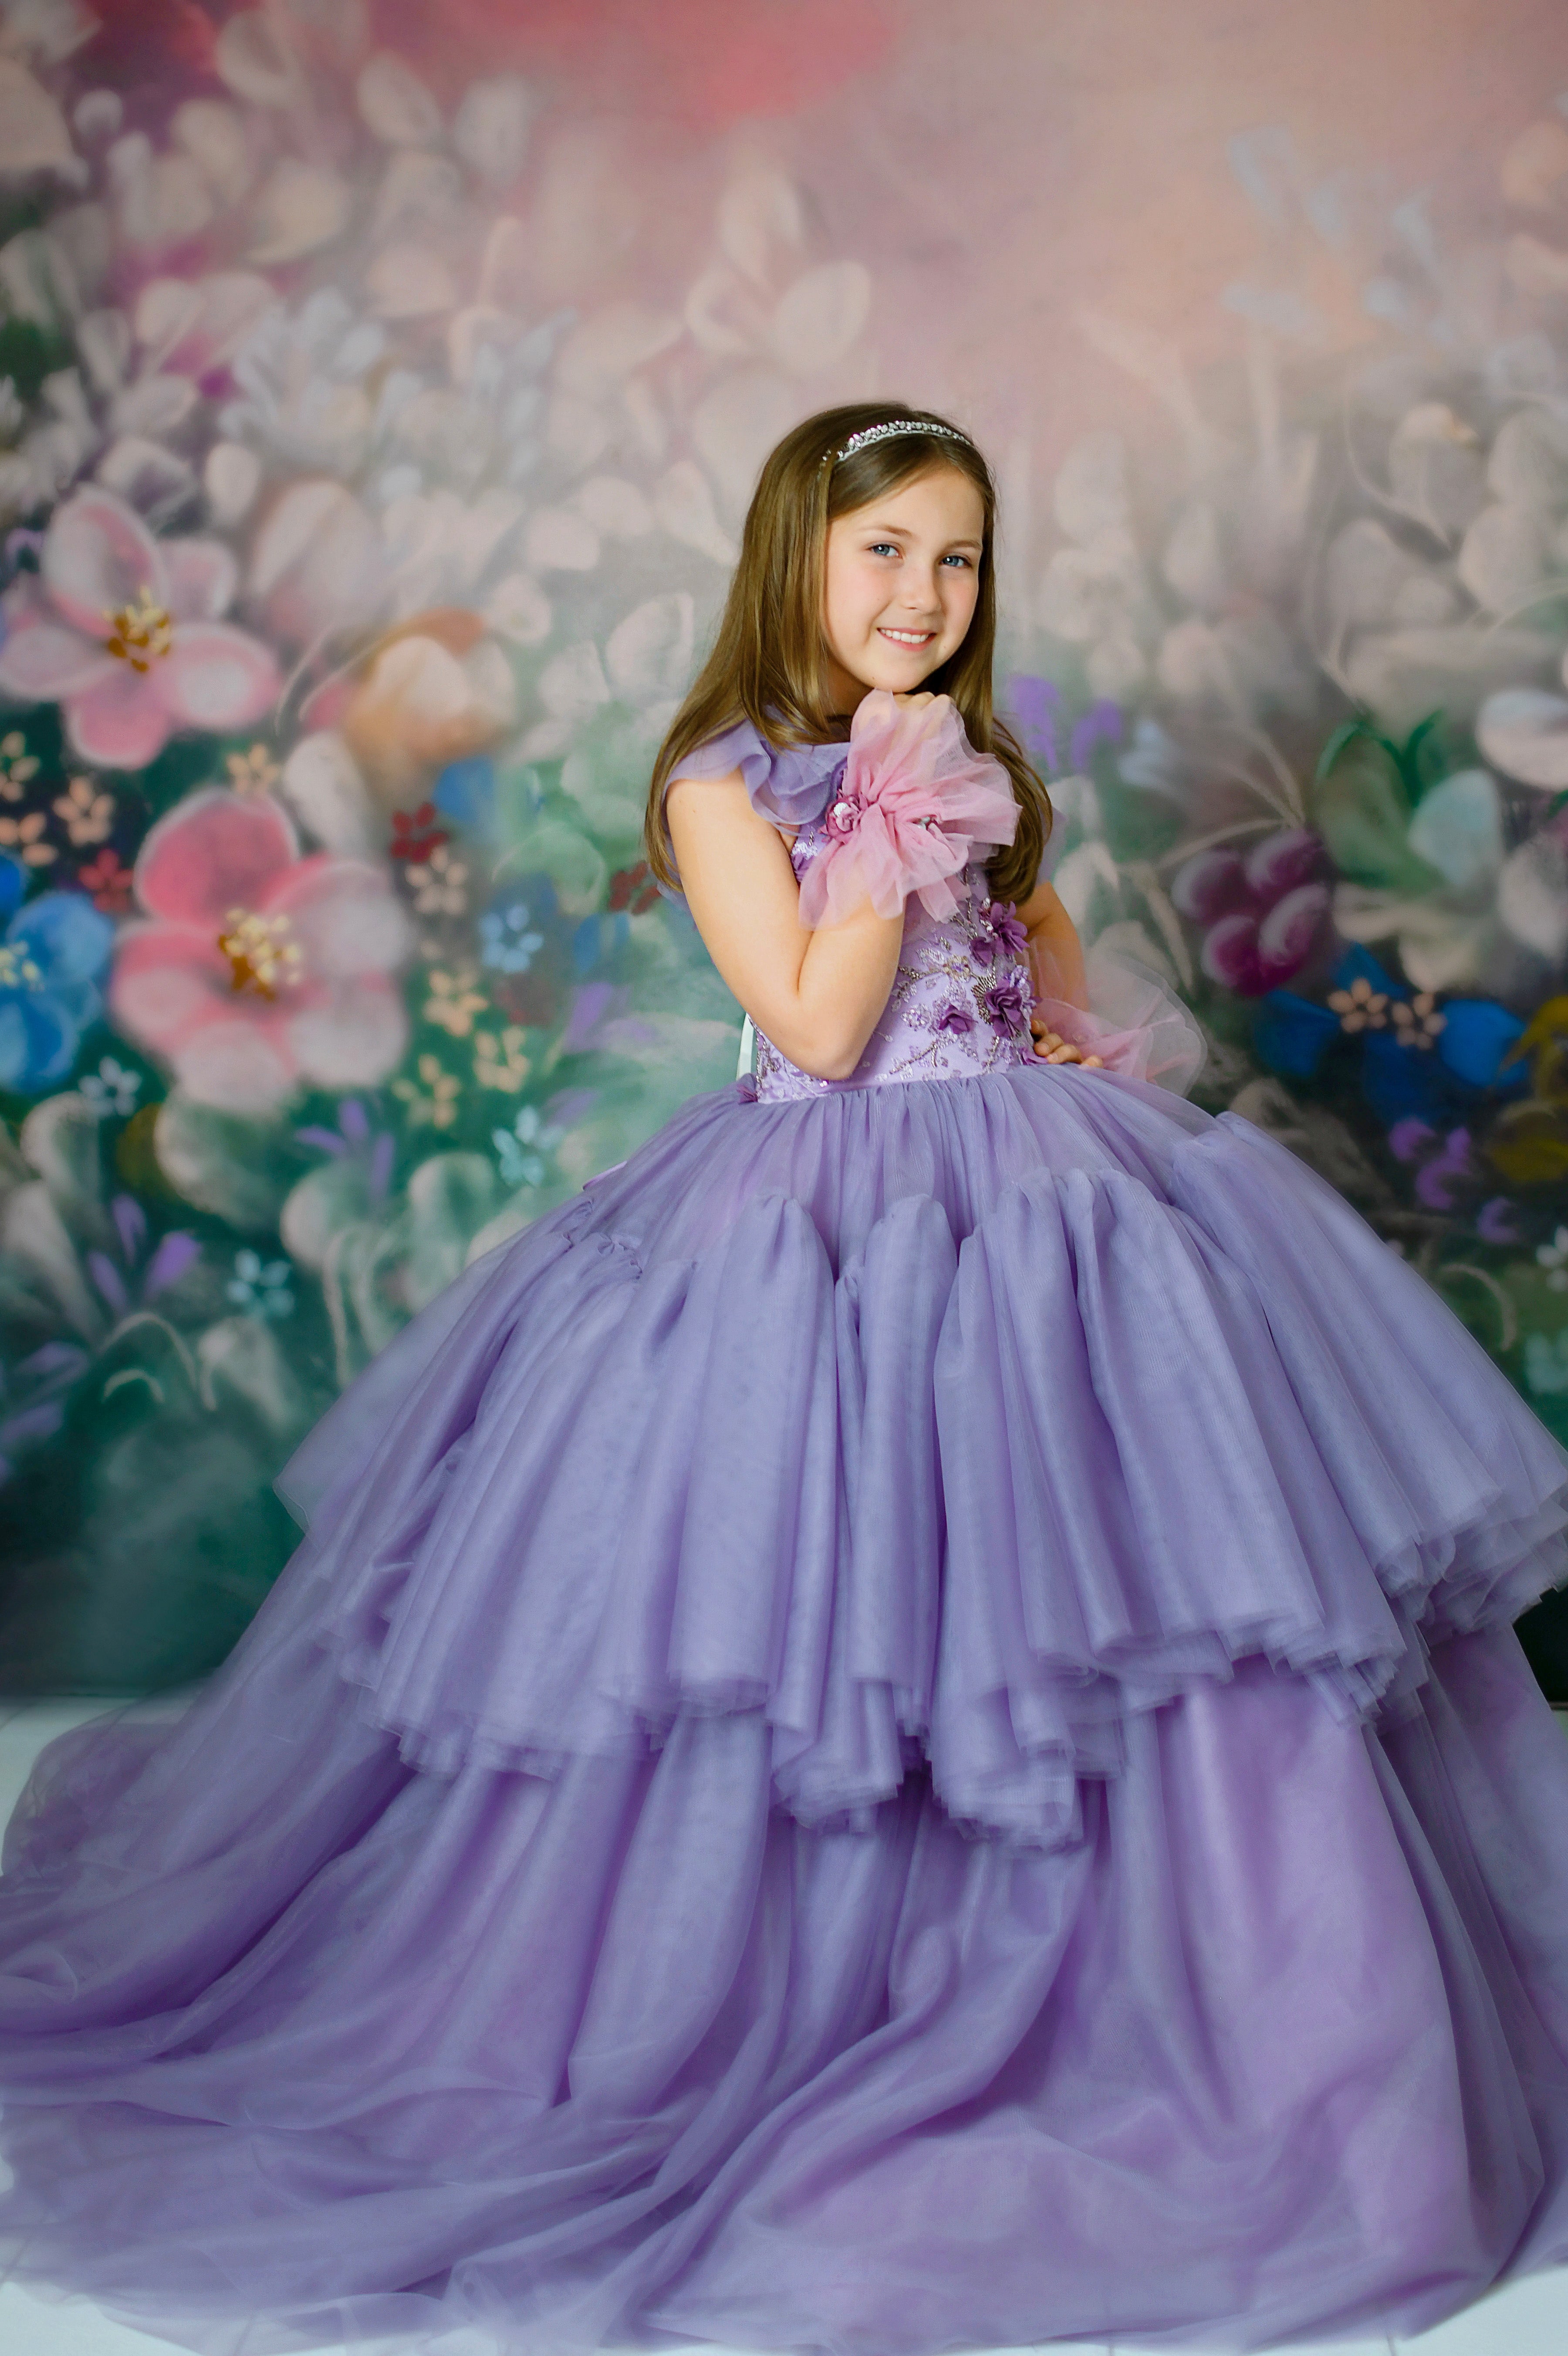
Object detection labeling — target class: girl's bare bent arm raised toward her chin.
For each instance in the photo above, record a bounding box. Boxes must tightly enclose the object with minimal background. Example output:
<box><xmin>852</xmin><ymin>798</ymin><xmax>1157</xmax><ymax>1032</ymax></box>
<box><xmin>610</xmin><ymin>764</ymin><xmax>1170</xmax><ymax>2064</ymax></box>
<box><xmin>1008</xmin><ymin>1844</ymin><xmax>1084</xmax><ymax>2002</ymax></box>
<box><xmin>664</xmin><ymin>770</ymin><xmax>904</xmax><ymax>1079</ymax></box>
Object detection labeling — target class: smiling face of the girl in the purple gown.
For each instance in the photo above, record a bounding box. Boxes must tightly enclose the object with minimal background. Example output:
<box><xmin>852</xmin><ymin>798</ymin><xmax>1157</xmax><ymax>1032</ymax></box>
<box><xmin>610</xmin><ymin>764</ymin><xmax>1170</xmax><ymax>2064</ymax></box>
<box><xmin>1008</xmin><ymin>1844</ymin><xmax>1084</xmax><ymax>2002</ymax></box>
<box><xmin>821</xmin><ymin>467</ymin><xmax>984</xmax><ymax>711</ymax></box>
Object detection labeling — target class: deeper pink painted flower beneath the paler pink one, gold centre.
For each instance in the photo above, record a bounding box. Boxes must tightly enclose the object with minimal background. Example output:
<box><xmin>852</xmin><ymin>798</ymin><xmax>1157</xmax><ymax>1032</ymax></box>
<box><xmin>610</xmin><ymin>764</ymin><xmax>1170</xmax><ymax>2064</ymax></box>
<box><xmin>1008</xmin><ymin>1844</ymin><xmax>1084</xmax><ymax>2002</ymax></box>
<box><xmin>108</xmin><ymin>787</ymin><xmax>410</xmax><ymax>1112</ymax></box>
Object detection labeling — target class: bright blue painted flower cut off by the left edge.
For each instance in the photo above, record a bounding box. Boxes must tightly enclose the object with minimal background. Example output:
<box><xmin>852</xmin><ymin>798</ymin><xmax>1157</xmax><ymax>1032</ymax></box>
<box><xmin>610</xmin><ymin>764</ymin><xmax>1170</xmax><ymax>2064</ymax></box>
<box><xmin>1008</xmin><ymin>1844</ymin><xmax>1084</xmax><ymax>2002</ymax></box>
<box><xmin>0</xmin><ymin>855</ymin><xmax>115</xmax><ymax>1096</ymax></box>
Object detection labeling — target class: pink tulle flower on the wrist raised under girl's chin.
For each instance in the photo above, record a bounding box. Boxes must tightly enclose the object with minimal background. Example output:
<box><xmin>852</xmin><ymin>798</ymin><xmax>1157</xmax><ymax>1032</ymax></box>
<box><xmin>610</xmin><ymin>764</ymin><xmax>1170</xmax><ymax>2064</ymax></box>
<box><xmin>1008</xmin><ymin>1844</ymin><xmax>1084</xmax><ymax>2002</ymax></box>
<box><xmin>801</xmin><ymin>688</ymin><xmax>1017</xmax><ymax>926</ymax></box>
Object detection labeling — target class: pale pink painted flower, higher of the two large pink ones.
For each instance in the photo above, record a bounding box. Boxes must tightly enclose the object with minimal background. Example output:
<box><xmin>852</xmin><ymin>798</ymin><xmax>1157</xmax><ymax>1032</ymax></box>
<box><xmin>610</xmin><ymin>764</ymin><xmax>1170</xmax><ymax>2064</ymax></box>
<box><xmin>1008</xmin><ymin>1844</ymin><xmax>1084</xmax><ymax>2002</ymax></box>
<box><xmin>0</xmin><ymin>483</ymin><xmax>280</xmax><ymax>768</ymax></box>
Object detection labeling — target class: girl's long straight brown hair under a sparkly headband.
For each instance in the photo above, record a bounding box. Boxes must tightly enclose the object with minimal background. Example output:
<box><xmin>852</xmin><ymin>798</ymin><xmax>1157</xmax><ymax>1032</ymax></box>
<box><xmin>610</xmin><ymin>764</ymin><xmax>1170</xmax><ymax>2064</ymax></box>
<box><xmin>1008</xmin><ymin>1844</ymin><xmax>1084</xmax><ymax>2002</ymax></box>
<box><xmin>643</xmin><ymin>400</ymin><xmax>1052</xmax><ymax>900</ymax></box>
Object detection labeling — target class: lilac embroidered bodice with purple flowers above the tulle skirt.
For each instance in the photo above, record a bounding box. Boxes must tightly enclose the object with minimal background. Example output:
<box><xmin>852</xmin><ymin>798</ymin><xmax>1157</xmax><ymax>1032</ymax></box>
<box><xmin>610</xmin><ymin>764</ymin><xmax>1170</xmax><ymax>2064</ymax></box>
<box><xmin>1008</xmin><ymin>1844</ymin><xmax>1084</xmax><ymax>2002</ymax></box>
<box><xmin>756</xmin><ymin>825</ymin><xmax>1034</xmax><ymax>1103</ymax></box>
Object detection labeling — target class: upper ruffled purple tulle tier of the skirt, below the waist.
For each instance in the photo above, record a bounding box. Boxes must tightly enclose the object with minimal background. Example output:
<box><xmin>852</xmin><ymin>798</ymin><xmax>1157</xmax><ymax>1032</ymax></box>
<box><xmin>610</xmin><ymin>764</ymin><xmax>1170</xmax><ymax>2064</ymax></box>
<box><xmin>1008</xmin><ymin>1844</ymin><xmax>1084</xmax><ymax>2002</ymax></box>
<box><xmin>272</xmin><ymin>1065</ymin><xmax>1568</xmax><ymax>1847</ymax></box>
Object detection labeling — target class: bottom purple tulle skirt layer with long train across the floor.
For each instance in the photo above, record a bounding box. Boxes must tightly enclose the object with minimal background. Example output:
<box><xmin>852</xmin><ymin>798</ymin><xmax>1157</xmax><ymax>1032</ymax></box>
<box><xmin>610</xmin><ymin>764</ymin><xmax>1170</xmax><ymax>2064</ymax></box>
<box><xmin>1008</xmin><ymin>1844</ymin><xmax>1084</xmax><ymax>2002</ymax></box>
<box><xmin>0</xmin><ymin>1621</ymin><xmax>1568</xmax><ymax>2356</ymax></box>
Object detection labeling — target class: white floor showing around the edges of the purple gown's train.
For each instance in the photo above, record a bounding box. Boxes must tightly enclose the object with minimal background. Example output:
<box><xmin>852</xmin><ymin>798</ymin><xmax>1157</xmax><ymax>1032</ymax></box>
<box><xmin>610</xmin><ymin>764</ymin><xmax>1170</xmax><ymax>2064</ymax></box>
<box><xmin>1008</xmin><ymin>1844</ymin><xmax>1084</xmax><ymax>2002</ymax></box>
<box><xmin>0</xmin><ymin>1701</ymin><xmax>1568</xmax><ymax>2356</ymax></box>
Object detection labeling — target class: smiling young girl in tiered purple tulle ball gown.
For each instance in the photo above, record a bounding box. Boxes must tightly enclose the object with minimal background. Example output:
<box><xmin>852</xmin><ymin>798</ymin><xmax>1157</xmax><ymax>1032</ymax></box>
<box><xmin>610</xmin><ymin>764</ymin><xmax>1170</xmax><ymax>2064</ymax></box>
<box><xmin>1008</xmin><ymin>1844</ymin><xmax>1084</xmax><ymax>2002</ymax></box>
<box><xmin>0</xmin><ymin>405</ymin><xmax>1568</xmax><ymax>2356</ymax></box>
